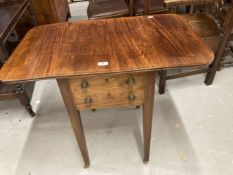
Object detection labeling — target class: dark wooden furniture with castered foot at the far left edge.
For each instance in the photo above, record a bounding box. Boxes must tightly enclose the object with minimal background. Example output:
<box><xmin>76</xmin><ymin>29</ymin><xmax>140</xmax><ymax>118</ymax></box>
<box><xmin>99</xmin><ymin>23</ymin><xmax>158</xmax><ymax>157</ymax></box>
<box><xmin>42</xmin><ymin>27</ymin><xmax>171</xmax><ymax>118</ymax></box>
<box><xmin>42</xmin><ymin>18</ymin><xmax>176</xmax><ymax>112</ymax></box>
<box><xmin>0</xmin><ymin>0</ymin><xmax>35</xmax><ymax>116</ymax></box>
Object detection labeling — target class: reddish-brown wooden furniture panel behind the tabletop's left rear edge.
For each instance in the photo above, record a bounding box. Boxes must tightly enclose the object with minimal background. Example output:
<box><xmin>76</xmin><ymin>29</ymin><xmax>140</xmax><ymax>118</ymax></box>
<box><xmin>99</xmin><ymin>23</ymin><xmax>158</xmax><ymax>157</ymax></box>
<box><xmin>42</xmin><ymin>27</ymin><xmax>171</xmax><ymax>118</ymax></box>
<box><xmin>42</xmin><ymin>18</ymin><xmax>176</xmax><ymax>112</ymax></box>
<box><xmin>31</xmin><ymin>0</ymin><xmax>70</xmax><ymax>25</ymax></box>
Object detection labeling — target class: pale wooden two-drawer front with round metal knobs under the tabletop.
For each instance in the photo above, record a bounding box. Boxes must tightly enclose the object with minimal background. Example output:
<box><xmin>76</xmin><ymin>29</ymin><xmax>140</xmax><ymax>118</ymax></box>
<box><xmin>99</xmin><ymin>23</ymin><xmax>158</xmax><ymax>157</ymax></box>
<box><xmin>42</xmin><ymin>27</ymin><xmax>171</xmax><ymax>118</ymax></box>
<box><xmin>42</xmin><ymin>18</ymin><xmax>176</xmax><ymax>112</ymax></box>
<box><xmin>69</xmin><ymin>73</ymin><xmax>144</xmax><ymax>109</ymax></box>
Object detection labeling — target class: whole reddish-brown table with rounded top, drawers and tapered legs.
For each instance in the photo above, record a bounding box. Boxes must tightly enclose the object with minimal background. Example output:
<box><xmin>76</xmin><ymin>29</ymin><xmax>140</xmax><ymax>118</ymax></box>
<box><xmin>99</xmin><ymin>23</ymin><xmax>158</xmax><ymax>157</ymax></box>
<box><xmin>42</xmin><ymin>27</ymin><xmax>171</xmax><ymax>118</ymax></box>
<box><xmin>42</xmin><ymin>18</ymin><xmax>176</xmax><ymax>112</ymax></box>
<box><xmin>0</xmin><ymin>14</ymin><xmax>214</xmax><ymax>167</ymax></box>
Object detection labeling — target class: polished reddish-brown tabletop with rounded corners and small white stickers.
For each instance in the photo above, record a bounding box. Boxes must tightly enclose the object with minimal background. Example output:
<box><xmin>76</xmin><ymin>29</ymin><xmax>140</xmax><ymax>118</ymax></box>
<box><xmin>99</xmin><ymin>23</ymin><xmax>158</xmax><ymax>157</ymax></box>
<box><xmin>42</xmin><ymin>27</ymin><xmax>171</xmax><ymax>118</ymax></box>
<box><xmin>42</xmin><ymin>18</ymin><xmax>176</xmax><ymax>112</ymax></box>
<box><xmin>0</xmin><ymin>14</ymin><xmax>214</xmax><ymax>82</ymax></box>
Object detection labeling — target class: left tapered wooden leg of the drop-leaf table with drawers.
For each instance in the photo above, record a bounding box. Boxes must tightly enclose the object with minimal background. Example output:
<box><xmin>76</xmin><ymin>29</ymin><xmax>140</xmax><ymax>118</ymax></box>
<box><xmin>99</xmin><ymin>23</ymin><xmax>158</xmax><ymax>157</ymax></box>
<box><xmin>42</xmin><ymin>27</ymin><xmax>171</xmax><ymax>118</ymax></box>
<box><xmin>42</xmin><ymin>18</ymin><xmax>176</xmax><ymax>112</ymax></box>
<box><xmin>57</xmin><ymin>79</ymin><xmax>90</xmax><ymax>168</ymax></box>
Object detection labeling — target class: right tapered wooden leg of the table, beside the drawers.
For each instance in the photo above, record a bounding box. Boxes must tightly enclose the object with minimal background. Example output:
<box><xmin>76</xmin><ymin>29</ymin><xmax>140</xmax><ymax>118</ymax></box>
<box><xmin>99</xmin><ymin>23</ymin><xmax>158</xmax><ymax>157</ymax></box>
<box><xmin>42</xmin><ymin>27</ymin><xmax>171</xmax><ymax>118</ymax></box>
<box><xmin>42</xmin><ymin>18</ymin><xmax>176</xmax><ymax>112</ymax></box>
<box><xmin>143</xmin><ymin>72</ymin><xmax>156</xmax><ymax>163</ymax></box>
